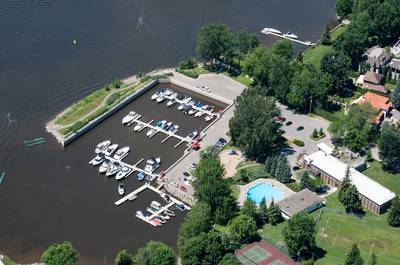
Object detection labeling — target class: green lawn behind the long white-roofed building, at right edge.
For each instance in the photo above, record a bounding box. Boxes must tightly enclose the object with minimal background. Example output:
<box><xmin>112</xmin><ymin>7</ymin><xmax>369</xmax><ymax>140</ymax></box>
<box><xmin>363</xmin><ymin>161</ymin><xmax>400</xmax><ymax>193</ymax></box>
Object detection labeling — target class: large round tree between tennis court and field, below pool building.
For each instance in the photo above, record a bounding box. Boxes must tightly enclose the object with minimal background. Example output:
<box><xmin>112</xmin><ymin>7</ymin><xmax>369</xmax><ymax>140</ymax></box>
<box><xmin>282</xmin><ymin>213</ymin><xmax>316</xmax><ymax>257</ymax></box>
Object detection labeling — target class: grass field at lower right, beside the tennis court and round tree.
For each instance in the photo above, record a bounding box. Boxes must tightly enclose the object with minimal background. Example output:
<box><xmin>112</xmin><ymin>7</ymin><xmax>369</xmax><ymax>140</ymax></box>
<box><xmin>262</xmin><ymin>193</ymin><xmax>400</xmax><ymax>265</ymax></box>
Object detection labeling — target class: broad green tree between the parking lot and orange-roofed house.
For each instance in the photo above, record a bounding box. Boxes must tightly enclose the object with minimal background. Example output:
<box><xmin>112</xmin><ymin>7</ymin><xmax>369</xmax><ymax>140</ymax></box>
<box><xmin>331</xmin><ymin>103</ymin><xmax>377</xmax><ymax>152</ymax></box>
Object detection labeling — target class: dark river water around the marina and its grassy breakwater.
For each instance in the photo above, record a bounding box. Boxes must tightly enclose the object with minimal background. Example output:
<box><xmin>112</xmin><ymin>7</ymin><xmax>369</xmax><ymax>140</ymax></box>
<box><xmin>0</xmin><ymin>0</ymin><xmax>334</xmax><ymax>264</ymax></box>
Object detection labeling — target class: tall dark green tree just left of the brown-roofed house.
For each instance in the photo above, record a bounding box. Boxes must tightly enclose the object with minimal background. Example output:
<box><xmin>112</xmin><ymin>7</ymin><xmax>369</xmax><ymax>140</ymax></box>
<box><xmin>320</xmin><ymin>51</ymin><xmax>351</xmax><ymax>95</ymax></box>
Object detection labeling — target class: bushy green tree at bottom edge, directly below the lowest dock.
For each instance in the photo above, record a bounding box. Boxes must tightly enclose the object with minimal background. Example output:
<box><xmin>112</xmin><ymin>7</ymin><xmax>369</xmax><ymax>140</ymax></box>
<box><xmin>137</xmin><ymin>240</ymin><xmax>176</xmax><ymax>265</ymax></box>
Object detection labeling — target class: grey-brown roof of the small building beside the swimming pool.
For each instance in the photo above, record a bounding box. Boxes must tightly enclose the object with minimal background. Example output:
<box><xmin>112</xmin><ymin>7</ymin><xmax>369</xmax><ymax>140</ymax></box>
<box><xmin>277</xmin><ymin>189</ymin><xmax>322</xmax><ymax>217</ymax></box>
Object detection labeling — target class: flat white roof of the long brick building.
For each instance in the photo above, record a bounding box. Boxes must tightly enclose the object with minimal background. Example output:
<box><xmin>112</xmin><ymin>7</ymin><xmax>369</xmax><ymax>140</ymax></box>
<box><xmin>304</xmin><ymin>151</ymin><xmax>396</xmax><ymax>205</ymax></box>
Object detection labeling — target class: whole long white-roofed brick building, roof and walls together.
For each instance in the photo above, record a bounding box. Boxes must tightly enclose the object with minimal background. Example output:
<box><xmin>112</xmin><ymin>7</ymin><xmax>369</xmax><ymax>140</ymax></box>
<box><xmin>304</xmin><ymin>151</ymin><xmax>396</xmax><ymax>214</ymax></box>
